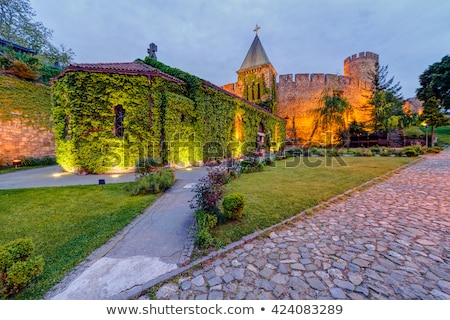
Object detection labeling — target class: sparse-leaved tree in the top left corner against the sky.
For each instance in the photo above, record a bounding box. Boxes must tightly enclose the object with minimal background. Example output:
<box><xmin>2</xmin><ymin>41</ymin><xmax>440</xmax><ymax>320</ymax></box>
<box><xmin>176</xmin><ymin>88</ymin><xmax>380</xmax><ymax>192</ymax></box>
<box><xmin>0</xmin><ymin>0</ymin><xmax>74</xmax><ymax>65</ymax></box>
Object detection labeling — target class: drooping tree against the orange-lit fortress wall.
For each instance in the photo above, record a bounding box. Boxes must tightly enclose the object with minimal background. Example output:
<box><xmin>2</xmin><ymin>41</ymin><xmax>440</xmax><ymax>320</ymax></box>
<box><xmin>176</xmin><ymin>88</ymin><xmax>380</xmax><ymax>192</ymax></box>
<box><xmin>311</xmin><ymin>88</ymin><xmax>353</xmax><ymax>144</ymax></box>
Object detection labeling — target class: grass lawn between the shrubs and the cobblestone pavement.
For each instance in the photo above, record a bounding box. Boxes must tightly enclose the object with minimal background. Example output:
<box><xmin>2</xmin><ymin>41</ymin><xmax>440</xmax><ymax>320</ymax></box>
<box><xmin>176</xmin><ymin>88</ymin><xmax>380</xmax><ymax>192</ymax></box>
<box><xmin>213</xmin><ymin>157</ymin><xmax>412</xmax><ymax>244</ymax></box>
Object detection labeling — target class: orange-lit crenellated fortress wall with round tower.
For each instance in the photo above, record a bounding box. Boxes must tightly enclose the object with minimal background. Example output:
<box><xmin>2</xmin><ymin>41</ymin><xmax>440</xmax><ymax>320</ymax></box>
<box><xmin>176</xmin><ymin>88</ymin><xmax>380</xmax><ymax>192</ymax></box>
<box><xmin>277</xmin><ymin>52</ymin><xmax>378</xmax><ymax>142</ymax></box>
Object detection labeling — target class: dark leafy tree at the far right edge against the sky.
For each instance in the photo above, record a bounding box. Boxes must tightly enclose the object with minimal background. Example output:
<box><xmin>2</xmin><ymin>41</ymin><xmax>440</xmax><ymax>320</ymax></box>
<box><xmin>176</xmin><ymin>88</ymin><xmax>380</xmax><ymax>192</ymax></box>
<box><xmin>416</xmin><ymin>55</ymin><xmax>450</xmax><ymax>111</ymax></box>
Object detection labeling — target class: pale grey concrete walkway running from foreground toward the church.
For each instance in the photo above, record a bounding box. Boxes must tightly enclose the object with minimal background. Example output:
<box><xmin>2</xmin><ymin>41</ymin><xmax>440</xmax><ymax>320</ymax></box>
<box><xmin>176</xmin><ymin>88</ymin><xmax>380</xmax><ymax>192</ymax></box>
<box><xmin>38</xmin><ymin>168</ymin><xmax>207</xmax><ymax>300</ymax></box>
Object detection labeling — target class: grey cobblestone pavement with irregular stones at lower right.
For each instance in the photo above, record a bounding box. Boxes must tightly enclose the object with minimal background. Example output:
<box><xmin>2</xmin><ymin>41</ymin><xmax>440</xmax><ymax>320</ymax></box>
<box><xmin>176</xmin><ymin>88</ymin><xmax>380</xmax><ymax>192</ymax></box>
<box><xmin>156</xmin><ymin>149</ymin><xmax>450</xmax><ymax>300</ymax></box>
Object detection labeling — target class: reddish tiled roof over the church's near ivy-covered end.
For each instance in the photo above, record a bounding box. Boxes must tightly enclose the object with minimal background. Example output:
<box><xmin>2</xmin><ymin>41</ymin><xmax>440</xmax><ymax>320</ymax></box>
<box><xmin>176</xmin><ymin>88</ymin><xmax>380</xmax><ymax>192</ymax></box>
<box><xmin>55</xmin><ymin>61</ymin><xmax>183</xmax><ymax>83</ymax></box>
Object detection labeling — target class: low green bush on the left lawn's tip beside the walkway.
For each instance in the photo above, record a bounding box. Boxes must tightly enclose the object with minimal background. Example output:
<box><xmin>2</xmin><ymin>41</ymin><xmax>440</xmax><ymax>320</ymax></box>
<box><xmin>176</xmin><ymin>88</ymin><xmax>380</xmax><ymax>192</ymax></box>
<box><xmin>127</xmin><ymin>169</ymin><xmax>175</xmax><ymax>196</ymax></box>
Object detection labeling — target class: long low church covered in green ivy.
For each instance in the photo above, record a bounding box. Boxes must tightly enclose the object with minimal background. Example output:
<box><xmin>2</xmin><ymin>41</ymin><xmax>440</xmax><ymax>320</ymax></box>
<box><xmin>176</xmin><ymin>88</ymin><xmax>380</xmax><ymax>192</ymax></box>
<box><xmin>52</xmin><ymin>57</ymin><xmax>285</xmax><ymax>173</ymax></box>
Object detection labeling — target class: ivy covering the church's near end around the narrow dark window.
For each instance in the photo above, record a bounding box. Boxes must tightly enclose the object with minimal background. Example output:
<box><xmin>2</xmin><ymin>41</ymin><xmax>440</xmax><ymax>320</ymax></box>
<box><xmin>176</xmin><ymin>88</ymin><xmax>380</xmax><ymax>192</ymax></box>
<box><xmin>52</xmin><ymin>72</ymin><xmax>152</xmax><ymax>173</ymax></box>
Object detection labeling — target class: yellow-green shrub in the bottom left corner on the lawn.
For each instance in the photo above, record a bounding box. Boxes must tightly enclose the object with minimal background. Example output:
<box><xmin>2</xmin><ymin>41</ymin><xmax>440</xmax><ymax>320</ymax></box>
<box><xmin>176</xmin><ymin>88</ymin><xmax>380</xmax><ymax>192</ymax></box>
<box><xmin>0</xmin><ymin>239</ymin><xmax>44</xmax><ymax>297</ymax></box>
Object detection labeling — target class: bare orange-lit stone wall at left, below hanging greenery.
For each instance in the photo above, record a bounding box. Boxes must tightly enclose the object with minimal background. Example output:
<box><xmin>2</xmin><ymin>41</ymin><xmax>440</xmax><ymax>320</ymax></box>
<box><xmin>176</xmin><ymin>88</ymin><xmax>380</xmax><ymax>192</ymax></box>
<box><xmin>0</xmin><ymin>119</ymin><xmax>55</xmax><ymax>165</ymax></box>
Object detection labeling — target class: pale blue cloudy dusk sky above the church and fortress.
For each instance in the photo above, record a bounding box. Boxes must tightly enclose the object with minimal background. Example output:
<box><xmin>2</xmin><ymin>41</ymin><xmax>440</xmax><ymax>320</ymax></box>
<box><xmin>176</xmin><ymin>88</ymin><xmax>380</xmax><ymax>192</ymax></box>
<box><xmin>30</xmin><ymin>0</ymin><xmax>450</xmax><ymax>98</ymax></box>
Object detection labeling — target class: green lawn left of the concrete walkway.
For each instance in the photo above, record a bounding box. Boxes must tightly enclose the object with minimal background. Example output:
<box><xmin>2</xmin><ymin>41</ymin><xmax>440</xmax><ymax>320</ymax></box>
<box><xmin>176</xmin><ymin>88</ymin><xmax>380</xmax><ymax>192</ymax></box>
<box><xmin>0</xmin><ymin>184</ymin><xmax>157</xmax><ymax>299</ymax></box>
